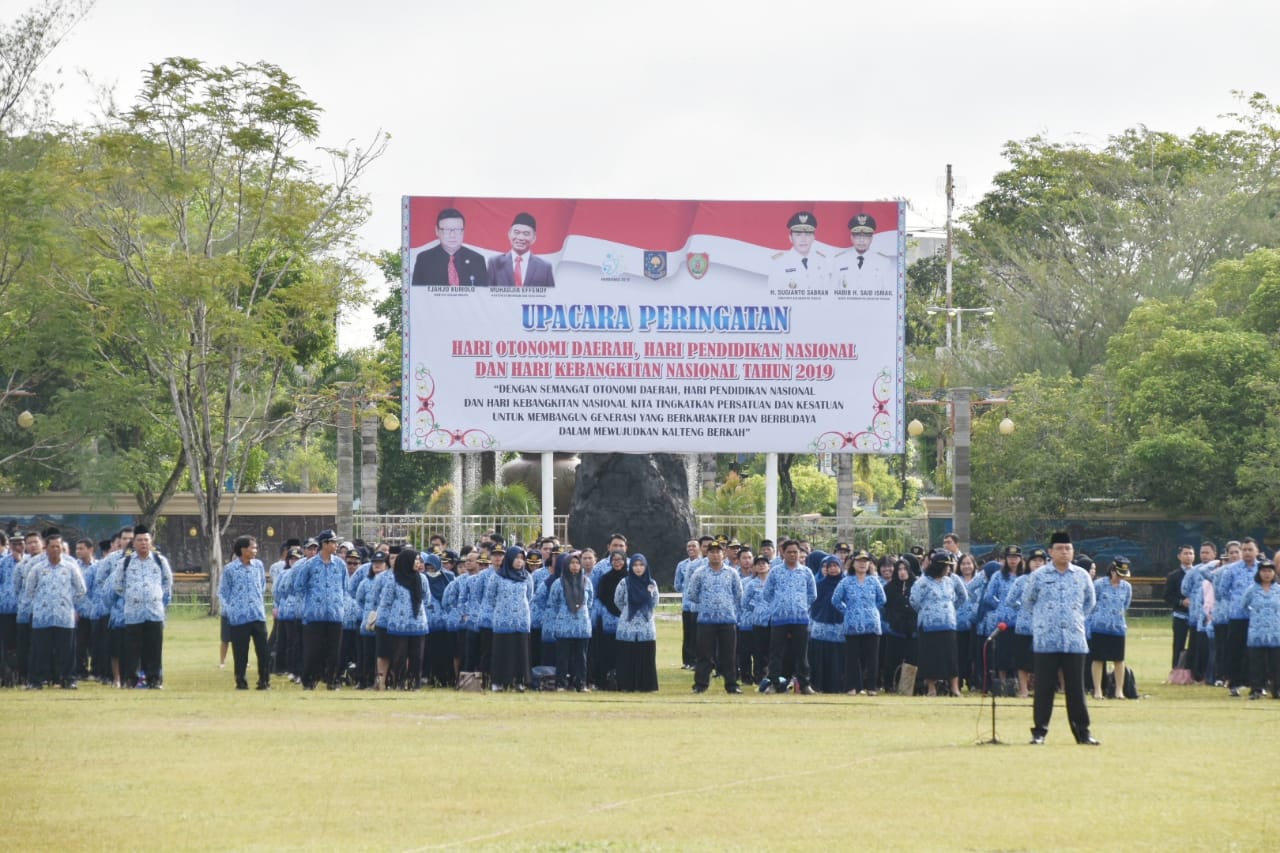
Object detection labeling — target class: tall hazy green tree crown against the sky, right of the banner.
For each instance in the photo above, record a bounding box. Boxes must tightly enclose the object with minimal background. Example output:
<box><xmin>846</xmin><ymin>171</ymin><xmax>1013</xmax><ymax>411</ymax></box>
<box><xmin>961</xmin><ymin>95</ymin><xmax>1280</xmax><ymax>378</ymax></box>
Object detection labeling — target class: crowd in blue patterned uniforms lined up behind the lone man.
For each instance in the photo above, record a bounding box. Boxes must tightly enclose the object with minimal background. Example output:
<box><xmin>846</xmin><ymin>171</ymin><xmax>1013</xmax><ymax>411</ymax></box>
<box><xmin>0</xmin><ymin>526</ymin><xmax>1280</xmax><ymax>712</ymax></box>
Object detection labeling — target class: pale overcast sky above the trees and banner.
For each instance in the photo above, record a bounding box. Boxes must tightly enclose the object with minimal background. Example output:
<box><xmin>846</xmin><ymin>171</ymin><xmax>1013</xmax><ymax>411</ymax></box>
<box><xmin>35</xmin><ymin>0</ymin><xmax>1280</xmax><ymax>347</ymax></box>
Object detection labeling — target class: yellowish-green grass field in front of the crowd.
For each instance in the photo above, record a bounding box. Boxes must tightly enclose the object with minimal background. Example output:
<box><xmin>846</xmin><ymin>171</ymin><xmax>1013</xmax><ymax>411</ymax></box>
<box><xmin>0</xmin><ymin>615</ymin><xmax>1280</xmax><ymax>850</ymax></box>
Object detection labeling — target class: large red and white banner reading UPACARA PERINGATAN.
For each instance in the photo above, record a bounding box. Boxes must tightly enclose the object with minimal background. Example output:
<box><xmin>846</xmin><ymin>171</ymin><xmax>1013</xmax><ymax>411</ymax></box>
<box><xmin>401</xmin><ymin>196</ymin><xmax>906</xmax><ymax>453</ymax></box>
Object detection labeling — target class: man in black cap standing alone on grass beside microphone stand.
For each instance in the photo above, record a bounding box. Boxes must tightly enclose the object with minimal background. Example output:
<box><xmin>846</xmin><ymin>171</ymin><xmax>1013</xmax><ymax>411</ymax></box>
<box><xmin>1025</xmin><ymin>532</ymin><xmax>1098</xmax><ymax>747</ymax></box>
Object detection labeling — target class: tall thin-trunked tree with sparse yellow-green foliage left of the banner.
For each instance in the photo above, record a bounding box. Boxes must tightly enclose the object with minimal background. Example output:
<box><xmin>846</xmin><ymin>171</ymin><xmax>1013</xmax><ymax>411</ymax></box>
<box><xmin>60</xmin><ymin>59</ymin><xmax>384</xmax><ymax>604</ymax></box>
